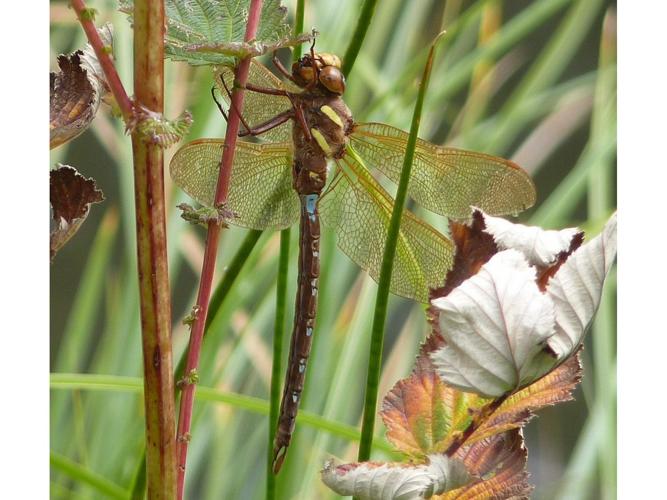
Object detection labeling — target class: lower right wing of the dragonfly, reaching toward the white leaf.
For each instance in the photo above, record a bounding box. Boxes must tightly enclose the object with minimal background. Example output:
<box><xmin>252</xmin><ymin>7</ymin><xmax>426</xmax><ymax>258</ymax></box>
<box><xmin>318</xmin><ymin>146</ymin><xmax>454</xmax><ymax>303</ymax></box>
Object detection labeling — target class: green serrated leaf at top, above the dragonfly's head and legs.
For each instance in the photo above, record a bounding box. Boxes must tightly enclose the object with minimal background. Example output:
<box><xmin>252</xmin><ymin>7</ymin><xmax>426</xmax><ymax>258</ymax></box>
<box><xmin>120</xmin><ymin>0</ymin><xmax>308</xmax><ymax>66</ymax></box>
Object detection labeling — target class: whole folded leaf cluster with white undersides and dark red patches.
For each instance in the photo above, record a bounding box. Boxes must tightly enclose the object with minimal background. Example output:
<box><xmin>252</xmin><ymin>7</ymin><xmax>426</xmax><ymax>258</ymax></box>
<box><xmin>429</xmin><ymin>212</ymin><xmax>616</xmax><ymax>397</ymax></box>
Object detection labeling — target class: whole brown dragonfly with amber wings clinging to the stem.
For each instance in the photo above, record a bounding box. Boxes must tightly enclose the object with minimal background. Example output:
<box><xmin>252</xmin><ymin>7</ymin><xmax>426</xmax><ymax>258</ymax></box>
<box><xmin>170</xmin><ymin>47</ymin><xmax>535</xmax><ymax>474</ymax></box>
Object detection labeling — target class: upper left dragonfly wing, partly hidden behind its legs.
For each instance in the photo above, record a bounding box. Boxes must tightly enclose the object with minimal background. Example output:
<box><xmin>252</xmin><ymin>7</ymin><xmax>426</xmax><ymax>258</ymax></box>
<box><xmin>215</xmin><ymin>59</ymin><xmax>292</xmax><ymax>142</ymax></box>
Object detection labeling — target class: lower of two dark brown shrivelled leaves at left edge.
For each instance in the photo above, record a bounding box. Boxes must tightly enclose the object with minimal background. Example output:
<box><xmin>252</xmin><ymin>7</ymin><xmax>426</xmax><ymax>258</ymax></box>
<box><xmin>50</xmin><ymin>165</ymin><xmax>104</xmax><ymax>259</ymax></box>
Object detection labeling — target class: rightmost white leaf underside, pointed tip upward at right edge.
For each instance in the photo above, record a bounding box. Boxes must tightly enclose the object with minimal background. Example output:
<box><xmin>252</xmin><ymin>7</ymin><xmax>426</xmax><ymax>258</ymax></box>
<box><xmin>547</xmin><ymin>214</ymin><xmax>616</xmax><ymax>359</ymax></box>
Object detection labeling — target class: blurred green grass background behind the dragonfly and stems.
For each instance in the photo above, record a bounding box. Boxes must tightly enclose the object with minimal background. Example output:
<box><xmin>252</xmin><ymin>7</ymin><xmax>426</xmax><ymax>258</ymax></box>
<box><xmin>51</xmin><ymin>0</ymin><xmax>616</xmax><ymax>500</ymax></box>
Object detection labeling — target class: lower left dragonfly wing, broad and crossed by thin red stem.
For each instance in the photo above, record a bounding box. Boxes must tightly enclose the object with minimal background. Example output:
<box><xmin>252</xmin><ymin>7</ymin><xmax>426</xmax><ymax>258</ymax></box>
<box><xmin>169</xmin><ymin>139</ymin><xmax>299</xmax><ymax>229</ymax></box>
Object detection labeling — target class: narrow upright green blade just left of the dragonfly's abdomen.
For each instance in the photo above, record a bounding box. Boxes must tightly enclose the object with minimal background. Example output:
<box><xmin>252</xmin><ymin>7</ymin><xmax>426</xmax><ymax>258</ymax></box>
<box><xmin>266</xmin><ymin>229</ymin><xmax>290</xmax><ymax>500</ymax></box>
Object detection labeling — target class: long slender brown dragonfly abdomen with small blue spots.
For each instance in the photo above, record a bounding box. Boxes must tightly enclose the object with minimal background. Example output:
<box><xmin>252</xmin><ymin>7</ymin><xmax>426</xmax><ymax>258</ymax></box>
<box><xmin>273</xmin><ymin>194</ymin><xmax>320</xmax><ymax>473</ymax></box>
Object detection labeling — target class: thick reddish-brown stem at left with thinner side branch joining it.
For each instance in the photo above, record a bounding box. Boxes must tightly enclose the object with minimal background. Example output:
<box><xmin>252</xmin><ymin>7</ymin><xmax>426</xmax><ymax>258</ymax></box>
<box><xmin>71</xmin><ymin>0</ymin><xmax>176</xmax><ymax>500</ymax></box>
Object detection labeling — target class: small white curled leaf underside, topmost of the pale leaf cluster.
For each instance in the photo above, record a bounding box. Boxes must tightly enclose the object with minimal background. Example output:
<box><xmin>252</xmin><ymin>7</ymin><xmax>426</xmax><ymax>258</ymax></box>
<box><xmin>482</xmin><ymin>212</ymin><xmax>579</xmax><ymax>267</ymax></box>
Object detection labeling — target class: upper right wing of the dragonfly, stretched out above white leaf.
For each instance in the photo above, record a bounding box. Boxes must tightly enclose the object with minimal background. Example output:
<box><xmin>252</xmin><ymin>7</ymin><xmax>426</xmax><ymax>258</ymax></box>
<box><xmin>350</xmin><ymin>123</ymin><xmax>535</xmax><ymax>219</ymax></box>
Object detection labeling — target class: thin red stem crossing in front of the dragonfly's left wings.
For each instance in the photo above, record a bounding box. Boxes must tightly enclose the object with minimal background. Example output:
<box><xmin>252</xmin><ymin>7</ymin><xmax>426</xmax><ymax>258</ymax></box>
<box><xmin>177</xmin><ymin>0</ymin><xmax>262</xmax><ymax>500</ymax></box>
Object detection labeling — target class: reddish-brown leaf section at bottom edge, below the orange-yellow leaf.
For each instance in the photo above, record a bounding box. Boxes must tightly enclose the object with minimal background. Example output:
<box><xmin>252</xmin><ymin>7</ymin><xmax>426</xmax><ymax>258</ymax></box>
<box><xmin>433</xmin><ymin>429</ymin><xmax>532</xmax><ymax>500</ymax></box>
